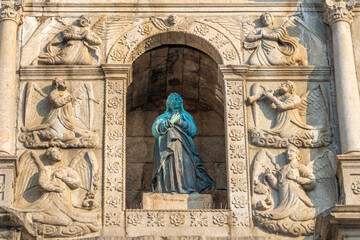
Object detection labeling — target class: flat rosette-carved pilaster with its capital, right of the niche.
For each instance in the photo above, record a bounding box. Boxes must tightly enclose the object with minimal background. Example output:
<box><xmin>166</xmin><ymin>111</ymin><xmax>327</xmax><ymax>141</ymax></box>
<box><xmin>220</xmin><ymin>65</ymin><xmax>251</xmax><ymax>236</ymax></box>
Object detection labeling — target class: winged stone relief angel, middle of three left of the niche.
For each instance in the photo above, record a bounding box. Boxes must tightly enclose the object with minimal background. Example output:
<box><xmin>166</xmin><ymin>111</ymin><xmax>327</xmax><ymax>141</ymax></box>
<box><xmin>19</xmin><ymin>78</ymin><xmax>99</xmax><ymax>148</ymax></box>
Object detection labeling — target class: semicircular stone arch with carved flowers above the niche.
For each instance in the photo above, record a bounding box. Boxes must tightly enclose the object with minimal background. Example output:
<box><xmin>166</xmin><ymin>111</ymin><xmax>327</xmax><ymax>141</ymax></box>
<box><xmin>107</xmin><ymin>17</ymin><xmax>242</xmax><ymax>69</ymax></box>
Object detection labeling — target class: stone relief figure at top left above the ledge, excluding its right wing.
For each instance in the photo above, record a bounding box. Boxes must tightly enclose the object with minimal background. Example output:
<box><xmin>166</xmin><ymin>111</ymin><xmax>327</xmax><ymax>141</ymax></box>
<box><xmin>33</xmin><ymin>16</ymin><xmax>102</xmax><ymax>65</ymax></box>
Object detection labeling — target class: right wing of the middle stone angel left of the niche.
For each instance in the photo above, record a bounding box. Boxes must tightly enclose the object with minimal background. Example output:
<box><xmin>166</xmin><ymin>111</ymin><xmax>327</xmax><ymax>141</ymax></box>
<box><xmin>73</xmin><ymin>83</ymin><xmax>100</xmax><ymax>130</ymax></box>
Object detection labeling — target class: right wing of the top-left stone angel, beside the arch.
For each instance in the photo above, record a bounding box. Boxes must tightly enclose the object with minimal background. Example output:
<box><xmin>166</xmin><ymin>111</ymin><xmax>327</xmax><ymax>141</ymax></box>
<box><xmin>91</xmin><ymin>16</ymin><xmax>132</xmax><ymax>41</ymax></box>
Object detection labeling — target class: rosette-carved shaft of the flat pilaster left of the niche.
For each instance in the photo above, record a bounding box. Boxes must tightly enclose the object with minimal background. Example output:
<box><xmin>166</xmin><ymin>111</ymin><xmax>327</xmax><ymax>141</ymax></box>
<box><xmin>104</xmin><ymin>80</ymin><xmax>125</xmax><ymax>227</ymax></box>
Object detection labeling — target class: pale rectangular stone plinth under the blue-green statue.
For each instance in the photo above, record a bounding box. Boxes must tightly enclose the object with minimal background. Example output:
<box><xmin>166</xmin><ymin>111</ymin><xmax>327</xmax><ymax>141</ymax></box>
<box><xmin>142</xmin><ymin>193</ymin><xmax>212</xmax><ymax>210</ymax></box>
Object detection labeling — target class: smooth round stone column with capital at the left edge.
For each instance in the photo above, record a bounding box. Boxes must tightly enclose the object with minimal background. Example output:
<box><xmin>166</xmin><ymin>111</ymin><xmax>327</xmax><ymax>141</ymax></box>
<box><xmin>0</xmin><ymin>1</ymin><xmax>20</xmax><ymax>155</ymax></box>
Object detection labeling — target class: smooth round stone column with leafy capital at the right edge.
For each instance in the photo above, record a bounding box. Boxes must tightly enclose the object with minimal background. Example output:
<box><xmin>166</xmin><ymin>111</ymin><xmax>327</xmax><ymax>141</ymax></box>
<box><xmin>324</xmin><ymin>0</ymin><xmax>360</xmax><ymax>154</ymax></box>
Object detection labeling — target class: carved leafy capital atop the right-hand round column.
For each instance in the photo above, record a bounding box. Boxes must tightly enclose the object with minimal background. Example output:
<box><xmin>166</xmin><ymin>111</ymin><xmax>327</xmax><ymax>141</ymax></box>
<box><xmin>323</xmin><ymin>0</ymin><xmax>355</xmax><ymax>26</ymax></box>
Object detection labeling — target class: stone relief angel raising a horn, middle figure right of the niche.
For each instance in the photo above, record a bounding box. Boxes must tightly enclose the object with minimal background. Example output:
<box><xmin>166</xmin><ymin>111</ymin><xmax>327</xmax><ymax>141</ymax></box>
<box><xmin>247</xmin><ymin>81</ymin><xmax>332</xmax><ymax>148</ymax></box>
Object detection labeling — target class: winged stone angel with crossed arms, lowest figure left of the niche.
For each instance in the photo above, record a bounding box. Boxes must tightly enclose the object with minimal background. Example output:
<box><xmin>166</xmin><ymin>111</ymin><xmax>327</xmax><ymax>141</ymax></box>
<box><xmin>14</xmin><ymin>147</ymin><xmax>100</xmax><ymax>237</ymax></box>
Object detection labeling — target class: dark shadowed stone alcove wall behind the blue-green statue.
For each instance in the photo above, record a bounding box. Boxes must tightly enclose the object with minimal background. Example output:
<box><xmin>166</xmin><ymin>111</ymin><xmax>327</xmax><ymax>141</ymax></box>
<box><xmin>126</xmin><ymin>45</ymin><xmax>227</xmax><ymax>209</ymax></box>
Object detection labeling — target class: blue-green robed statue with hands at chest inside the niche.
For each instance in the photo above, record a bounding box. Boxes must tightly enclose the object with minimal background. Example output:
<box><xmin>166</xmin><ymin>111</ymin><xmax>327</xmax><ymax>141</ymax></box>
<box><xmin>150</xmin><ymin>93</ymin><xmax>214</xmax><ymax>194</ymax></box>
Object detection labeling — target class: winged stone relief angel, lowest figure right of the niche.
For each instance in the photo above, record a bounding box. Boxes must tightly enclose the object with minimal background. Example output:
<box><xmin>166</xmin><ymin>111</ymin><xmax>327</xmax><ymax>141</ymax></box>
<box><xmin>252</xmin><ymin>145</ymin><xmax>336</xmax><ymax>236</ymax></box>
